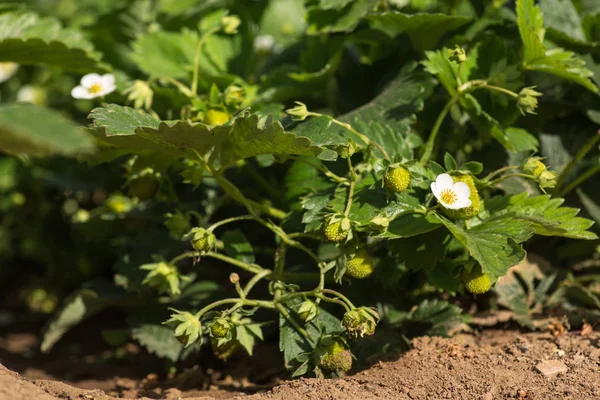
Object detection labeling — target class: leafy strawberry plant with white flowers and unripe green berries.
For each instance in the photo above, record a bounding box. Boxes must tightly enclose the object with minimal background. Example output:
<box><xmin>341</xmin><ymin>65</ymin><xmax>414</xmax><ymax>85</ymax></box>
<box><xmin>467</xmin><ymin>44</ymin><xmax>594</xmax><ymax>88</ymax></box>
<box><xmin>0</xmin><ymin>0</ymin><xmax>600</xmax><ymax>376</ymax></box>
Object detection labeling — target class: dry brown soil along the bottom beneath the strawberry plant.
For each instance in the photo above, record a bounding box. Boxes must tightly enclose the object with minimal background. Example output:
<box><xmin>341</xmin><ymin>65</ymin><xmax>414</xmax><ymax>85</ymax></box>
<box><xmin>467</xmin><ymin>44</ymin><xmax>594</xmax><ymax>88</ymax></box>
<box><xmin>0</xmin><ymin>330</ymin><xmax>600</xmax><ymax>400</ymax></box>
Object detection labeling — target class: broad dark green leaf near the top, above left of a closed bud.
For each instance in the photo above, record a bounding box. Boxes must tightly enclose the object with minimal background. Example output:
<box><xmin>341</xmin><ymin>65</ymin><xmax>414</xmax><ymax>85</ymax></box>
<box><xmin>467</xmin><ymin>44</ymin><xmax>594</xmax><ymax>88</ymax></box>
<box><xmin>367</xmin><ymin>12</ymin><xmax>471</xmax><ymax>51</ymax></box>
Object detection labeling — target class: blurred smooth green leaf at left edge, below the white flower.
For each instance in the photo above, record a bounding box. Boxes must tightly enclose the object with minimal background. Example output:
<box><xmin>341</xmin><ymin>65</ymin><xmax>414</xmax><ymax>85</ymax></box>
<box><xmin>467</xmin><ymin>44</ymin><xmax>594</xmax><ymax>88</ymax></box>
<box><xmin>0</xmin><ymin>104</ymin><xmax>94</xmax><ymax>157</ymax></box>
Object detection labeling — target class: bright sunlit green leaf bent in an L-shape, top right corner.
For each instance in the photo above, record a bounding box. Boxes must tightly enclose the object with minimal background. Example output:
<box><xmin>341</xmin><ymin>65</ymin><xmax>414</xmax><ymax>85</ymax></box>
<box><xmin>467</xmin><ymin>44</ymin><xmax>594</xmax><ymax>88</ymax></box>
<box><xmin>516</xmin><ymin>0</ymin><xmax>598</xmax><ymax>93</ymax></box>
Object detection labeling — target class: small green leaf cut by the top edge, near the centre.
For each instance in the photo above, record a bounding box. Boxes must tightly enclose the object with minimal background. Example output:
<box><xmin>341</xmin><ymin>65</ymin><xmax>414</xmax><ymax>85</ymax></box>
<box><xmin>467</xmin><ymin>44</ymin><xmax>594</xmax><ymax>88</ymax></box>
<box><xmin>306</xmin><ymin>0</ymin><xmax>378</xmax><ymax>35</ymax></box>
